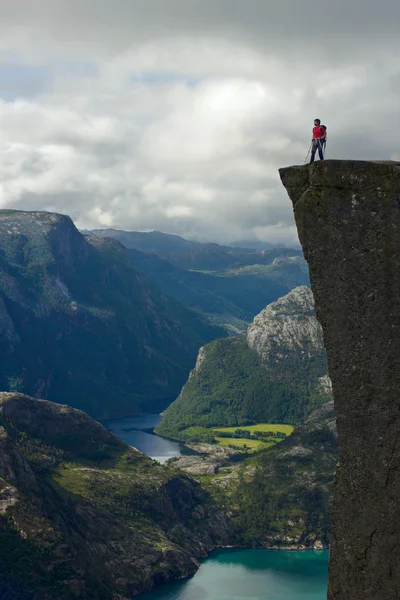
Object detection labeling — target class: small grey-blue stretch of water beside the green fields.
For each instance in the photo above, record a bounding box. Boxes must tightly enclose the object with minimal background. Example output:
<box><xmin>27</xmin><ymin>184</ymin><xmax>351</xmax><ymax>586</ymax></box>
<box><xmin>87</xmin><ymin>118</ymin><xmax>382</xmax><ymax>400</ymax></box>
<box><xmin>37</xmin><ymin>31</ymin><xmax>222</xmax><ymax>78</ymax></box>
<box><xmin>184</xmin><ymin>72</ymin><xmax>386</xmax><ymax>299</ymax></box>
<box><xmin>104</xmin><ymin>413</ymin><xmax>184</xmax><ymax>463</ymax></box>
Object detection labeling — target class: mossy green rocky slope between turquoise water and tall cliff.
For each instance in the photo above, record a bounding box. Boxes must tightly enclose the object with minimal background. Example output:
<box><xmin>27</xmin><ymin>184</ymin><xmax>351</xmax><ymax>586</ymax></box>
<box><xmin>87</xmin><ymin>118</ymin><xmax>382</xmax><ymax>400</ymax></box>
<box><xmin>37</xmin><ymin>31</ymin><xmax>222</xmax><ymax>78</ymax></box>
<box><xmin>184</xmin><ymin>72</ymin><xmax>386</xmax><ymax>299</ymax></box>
<box><xmin>203</xmin><ymin>400</ymin><xmax>339</xmax><ymax>549</ymax></box>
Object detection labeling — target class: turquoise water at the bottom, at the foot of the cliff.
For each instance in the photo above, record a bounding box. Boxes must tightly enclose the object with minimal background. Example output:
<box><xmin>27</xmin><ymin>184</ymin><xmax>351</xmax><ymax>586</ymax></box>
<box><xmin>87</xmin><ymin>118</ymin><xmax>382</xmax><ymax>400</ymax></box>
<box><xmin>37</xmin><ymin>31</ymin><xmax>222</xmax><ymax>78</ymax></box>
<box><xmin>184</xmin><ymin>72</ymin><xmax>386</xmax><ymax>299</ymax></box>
<box><xmin>139</xmin><ymin>550</ymin><xmax>328</xmax><ymax>600</ymax></box>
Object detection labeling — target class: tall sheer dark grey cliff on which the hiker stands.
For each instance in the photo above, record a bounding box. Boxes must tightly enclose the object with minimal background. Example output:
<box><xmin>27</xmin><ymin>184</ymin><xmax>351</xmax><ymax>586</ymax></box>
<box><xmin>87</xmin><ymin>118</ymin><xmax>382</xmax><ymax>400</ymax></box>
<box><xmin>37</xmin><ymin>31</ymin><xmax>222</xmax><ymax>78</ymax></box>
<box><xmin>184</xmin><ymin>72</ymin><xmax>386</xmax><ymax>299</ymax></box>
<box><xmin>280</xmin><ymin>161</ymin><xmax>400</xmax><ymax>600</ymax></box>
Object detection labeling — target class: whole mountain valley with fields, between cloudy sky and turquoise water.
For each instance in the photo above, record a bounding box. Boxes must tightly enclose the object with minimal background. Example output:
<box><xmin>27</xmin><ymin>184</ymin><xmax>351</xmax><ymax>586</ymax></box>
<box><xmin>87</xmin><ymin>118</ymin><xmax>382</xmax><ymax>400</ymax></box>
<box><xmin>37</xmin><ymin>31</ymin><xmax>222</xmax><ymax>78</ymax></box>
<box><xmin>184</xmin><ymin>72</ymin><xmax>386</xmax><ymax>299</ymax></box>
<box><xmin>0</xmin><ymin>211</ymin><xmax>338</xmax><ymax>600</ymax></box>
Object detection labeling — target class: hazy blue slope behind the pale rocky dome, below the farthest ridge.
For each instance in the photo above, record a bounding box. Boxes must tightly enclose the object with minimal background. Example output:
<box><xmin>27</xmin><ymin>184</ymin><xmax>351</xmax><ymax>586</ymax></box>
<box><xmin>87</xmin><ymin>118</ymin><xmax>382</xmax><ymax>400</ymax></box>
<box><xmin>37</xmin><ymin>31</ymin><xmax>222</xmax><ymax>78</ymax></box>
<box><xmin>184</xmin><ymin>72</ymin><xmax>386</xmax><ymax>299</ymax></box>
<box><xmin>128</xmin><ymin>249</ymin><xmax>309</xmax><ymax>333</ymax></box>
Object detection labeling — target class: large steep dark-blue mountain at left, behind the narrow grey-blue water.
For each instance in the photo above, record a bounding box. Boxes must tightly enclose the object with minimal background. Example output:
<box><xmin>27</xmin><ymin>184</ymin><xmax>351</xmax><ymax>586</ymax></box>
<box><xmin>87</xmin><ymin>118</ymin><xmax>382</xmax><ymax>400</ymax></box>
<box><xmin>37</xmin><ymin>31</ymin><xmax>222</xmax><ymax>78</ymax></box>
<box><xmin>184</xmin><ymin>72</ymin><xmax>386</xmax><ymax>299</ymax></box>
<box><xmin>0</xmin><ymin>210</ymin><xmax>224</xmax><ymax>417</ymax></box>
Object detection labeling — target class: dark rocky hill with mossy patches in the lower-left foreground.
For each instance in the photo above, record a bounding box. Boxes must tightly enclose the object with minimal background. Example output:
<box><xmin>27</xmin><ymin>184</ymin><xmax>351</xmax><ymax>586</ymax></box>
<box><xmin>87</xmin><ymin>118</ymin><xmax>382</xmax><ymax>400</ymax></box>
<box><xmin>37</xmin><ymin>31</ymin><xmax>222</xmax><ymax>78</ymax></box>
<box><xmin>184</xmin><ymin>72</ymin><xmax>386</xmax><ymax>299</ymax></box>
<box><xmin>0</xmin><ymin>393</ymin><xmax>231</xmax><ymax>600</ymax></box>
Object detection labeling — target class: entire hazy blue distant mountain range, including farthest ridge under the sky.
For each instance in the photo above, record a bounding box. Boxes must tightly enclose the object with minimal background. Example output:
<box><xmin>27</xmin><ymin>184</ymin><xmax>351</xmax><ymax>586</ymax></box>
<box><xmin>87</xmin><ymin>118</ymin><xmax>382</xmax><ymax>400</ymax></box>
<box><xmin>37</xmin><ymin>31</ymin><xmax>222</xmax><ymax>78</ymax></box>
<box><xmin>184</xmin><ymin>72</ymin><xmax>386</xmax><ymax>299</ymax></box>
<box><xmin>84</xmin><ymin>229</ymin><xmax>309</xmax><ymax>333</ymax></box>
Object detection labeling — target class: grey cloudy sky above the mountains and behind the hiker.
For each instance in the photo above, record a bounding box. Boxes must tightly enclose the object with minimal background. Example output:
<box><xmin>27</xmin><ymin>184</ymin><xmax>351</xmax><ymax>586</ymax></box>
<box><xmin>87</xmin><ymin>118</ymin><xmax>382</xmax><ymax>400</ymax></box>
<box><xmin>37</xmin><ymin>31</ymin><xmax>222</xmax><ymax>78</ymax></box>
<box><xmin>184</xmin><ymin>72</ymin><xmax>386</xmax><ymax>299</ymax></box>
<box><xmin>0</xmin><ymin>0</ymin><xmax>400</xmax><ymax>244</ymax></box>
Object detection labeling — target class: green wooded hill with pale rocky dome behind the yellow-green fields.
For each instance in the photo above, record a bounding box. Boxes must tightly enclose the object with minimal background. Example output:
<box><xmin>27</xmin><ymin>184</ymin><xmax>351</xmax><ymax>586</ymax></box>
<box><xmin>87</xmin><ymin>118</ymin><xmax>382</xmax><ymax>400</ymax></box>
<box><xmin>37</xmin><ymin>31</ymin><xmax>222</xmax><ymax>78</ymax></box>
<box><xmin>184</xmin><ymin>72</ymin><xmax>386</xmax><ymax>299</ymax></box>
<box><xmin>157</xmin><ymin>286</ymin><xmax>331</xmax><ymax>439</ymax></box>
